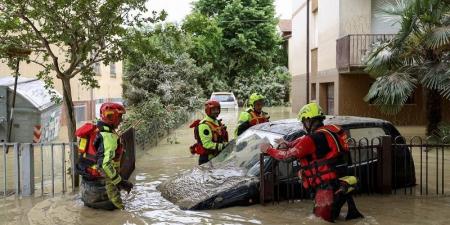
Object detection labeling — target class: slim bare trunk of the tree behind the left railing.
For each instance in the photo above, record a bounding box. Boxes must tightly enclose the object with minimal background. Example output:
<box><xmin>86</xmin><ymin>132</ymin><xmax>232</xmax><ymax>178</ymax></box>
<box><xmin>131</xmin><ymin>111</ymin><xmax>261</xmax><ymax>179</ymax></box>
<box><xmin>61</xmin><ymin>78</ymin><xmax>77</xmax><ymax>142</ymax></box>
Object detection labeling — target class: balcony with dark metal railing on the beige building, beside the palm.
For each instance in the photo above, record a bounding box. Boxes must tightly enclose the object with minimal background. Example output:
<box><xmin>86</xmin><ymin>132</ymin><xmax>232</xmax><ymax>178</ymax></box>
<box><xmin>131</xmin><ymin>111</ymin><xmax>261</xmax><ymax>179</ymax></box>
<box><xmin>336</xmin><ymin>34</ymin><xmax>395</xmax><ymax>74</ymax></box>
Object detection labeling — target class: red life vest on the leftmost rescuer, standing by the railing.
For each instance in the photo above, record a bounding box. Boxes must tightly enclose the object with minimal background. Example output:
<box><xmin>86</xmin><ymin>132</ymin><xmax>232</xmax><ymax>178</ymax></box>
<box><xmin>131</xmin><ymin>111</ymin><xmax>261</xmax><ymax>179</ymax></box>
<box><xmin>75</xmin><ymin>123</ymin><xmax>123</xmax><ymax>179</ymax></box>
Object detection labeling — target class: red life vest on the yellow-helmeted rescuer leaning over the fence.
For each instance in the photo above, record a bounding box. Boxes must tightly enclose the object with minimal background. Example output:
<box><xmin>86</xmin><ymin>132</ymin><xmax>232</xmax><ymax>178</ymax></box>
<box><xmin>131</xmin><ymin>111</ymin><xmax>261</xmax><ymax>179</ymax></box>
<box><xmin>300</xmin><ymin>125</ymin><xmax>349</xmax><ymax>188</ymax></box>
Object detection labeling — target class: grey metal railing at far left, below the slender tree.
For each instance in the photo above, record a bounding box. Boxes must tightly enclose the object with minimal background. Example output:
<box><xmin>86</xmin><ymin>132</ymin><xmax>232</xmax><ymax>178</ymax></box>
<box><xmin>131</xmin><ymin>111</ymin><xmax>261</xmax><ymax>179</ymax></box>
<box><xmin>0</xmin><ymin>143</ymin><xmax>77</xmax><ymax>197</ymax></box>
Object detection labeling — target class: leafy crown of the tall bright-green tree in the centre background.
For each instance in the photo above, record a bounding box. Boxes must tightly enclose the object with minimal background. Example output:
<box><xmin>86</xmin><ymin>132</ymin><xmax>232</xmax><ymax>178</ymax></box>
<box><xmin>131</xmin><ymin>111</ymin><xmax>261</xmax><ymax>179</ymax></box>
<box><xmin>183</xmin><ymin>0</ymin><xmax>282</xmax><ymax>97</ymax></box>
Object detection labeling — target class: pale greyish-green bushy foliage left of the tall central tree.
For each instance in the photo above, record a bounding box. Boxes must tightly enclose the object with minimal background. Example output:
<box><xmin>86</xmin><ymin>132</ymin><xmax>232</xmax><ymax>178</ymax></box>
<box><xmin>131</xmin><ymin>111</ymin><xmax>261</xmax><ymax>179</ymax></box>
<box><xmin>123</xmin><ymin>24</ymin><xmax>207</xmax><ymax>145</ymax></box>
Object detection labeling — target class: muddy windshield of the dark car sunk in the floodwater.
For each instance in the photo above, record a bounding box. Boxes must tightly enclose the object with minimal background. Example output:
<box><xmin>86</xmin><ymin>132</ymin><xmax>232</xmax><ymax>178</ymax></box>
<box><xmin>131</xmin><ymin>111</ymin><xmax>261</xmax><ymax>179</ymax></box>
<box><xmin>211</xmin><ymin>129</ymin><xmax>282</xmax><ymax>176</ymax></box>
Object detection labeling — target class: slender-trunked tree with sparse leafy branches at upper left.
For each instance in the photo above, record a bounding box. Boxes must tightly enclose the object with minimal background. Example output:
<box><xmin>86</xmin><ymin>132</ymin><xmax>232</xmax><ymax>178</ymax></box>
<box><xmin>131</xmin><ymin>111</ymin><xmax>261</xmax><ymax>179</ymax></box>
<box><xmin>0</xmin><ymin>0</ymin><xmax>165</xmax><ymax>141</ymax></box>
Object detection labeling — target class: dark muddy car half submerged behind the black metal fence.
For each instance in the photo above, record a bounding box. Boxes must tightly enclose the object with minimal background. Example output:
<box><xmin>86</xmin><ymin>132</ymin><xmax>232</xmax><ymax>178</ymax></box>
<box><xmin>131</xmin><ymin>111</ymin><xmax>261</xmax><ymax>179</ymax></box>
<box><xmin>158</xmin><ymin>116</ymin><xmax>415</xmax><ymax>209</ymax></box>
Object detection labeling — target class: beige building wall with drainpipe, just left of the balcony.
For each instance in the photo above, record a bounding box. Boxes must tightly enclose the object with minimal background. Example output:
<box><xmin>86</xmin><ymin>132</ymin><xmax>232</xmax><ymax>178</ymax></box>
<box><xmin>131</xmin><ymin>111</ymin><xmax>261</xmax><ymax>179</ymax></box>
<box><xmin>289</xmin><ymin>0</ymin><xmax>340</xmax><ymax>113</ymax></box>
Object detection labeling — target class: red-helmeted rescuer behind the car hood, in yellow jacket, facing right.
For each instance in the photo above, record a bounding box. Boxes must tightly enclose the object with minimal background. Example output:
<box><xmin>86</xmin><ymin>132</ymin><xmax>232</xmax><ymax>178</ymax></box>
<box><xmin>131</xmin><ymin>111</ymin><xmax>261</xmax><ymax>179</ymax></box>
<box><xmin>191</xmin><ymin>100</ymin><xmax>228</xmax><ymax>165</ymax></box>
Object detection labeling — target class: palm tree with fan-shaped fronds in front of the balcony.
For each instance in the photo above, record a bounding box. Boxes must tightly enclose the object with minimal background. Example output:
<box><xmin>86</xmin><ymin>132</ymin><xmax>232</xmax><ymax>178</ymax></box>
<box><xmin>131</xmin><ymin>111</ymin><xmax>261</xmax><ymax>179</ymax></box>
<box><xmin>365</xmin><ymin>0</ymin><xmax>450</xmax><ymax>135</ymax></box>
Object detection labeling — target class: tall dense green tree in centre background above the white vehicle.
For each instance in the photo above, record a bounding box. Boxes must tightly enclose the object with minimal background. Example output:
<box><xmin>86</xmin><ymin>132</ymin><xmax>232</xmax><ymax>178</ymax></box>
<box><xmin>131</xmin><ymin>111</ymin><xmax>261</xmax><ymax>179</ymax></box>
<box><xmin>183</xmin><ymin>0</ymin><xmax>290</xmax><ymax>104</ymax></box>
